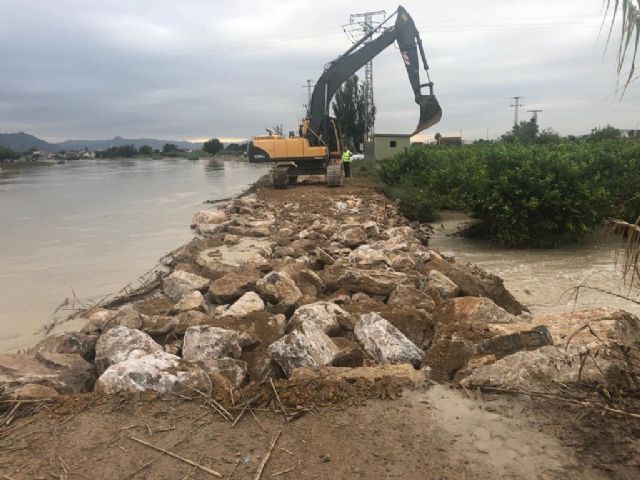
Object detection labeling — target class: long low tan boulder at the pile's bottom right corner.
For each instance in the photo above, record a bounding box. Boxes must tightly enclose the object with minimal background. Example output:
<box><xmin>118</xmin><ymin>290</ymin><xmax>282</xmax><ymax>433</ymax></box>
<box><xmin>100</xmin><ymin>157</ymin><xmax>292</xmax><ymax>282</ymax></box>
<box><xmin>461</xmin><ymin>346</ymin><xmax>610</xmax><ymax>390</ymax></box>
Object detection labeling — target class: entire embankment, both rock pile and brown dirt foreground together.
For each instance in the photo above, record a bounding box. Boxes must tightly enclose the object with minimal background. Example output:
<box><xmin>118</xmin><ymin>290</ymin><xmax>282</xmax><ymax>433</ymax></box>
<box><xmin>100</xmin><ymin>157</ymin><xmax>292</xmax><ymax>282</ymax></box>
<box><xmin>2</xmin><ymin>174</ymin><xmax>640</xmax><ymax>479</ymax></box>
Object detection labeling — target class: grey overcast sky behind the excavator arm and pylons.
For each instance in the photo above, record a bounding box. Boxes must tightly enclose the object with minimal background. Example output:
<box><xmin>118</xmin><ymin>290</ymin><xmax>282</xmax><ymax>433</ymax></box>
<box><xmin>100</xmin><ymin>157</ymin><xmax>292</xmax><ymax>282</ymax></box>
<box><xmin>0</xmin><ymin>0</ymin><xmax>640</xmax><ymax>141</ymax></box>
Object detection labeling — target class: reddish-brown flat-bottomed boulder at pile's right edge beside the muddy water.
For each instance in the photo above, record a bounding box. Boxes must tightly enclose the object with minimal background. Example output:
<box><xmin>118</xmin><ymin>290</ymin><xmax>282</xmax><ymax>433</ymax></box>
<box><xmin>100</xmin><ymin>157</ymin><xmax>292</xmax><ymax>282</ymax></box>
<box><xmin>433</xmin><ymin>297</ymin><xmax>520</xmax><ymax>323</ymax></box>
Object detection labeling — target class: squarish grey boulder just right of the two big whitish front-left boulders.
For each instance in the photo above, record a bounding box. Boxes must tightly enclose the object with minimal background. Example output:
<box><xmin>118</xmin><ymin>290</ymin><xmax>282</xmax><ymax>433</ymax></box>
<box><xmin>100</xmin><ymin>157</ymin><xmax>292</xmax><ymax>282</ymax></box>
<box><xmin>182</xmin><ymin>325</ymin><xmax>242</xmax><ymax>362</ymax></box>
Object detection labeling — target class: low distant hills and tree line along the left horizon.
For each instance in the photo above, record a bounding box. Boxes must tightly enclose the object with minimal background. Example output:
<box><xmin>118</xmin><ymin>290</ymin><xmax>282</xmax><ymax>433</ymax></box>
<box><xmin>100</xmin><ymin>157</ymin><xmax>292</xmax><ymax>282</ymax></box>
<box><xmin>0</xmin><ymin>132</ymin><xmax>202</xmax><ymax>152</ymax></box>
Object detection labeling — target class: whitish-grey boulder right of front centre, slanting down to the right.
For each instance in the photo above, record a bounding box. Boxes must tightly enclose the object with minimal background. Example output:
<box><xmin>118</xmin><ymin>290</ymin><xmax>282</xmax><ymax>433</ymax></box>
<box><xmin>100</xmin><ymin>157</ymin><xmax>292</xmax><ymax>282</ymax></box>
<box><xmin>354</xmin><ymin>313</ymin><xmax>424</xmax><ymax>367</ymax></box>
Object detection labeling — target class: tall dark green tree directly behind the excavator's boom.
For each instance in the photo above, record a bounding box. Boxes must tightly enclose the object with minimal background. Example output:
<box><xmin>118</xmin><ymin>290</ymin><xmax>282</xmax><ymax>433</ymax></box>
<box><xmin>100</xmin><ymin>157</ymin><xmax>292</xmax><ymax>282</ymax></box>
<box><xmin>333</xmin><ymin>75</ymin><xmax>376</xmax><ymax>150</ymax></box>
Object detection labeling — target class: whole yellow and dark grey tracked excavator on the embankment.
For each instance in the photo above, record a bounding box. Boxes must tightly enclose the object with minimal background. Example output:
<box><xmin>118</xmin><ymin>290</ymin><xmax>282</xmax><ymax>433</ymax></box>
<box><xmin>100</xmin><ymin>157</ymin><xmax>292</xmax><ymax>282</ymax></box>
<box><xmin>247</xmin><ymin>6</ymin><xmax>442</xmax><ymax>188</ymax></box>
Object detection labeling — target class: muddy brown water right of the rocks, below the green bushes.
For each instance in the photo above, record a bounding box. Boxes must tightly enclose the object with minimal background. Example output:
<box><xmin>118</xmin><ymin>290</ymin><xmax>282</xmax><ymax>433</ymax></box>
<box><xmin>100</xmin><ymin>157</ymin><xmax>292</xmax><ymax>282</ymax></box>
<box><xmin>430</xmin><ymin>212</ymin><xmax>640</xmax><ymax>316</ymax></box>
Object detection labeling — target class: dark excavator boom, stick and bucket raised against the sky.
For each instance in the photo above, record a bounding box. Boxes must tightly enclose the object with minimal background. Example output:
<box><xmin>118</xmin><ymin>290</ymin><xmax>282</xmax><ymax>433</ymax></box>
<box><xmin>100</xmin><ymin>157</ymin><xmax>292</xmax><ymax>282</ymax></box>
<box><xmin>307</xmin><ymin>6</ymin><xmax>442</xmax><ymax>145</ymax></box>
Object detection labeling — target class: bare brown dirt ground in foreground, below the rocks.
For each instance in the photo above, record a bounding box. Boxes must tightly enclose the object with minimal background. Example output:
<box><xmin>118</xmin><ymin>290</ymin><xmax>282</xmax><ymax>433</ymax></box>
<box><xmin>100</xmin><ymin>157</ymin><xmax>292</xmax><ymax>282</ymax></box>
<box><xmin>0</xmin><ymin>386</ymin><xmax>640</xmax><ymax>480</ymax></box>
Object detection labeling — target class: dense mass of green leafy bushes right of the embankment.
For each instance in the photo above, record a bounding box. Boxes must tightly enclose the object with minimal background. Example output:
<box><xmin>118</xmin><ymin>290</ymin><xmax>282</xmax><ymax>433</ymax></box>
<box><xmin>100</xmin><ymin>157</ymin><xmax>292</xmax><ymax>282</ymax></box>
<box><xmin>379</xmin><ymin>140</ymin><xmax>640</xmax><ymax>247</ymax></box>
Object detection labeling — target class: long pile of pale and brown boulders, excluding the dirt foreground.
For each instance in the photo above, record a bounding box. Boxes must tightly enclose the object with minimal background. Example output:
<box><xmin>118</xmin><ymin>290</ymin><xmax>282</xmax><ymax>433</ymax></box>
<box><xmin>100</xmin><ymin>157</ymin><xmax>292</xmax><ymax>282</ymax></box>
<box><xmin>5</xmin><ymin>189</ymin><xmax>640</xmax><ymax>398</ymax></box>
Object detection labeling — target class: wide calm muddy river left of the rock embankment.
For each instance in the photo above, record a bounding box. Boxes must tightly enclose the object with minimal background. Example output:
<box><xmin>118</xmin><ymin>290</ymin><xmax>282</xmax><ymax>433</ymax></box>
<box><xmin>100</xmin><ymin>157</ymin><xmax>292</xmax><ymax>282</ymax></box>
<box><xmin>0</xmin><ymin>159</ymin><xmax>266</xmax><ymax>352</ymax></box>
